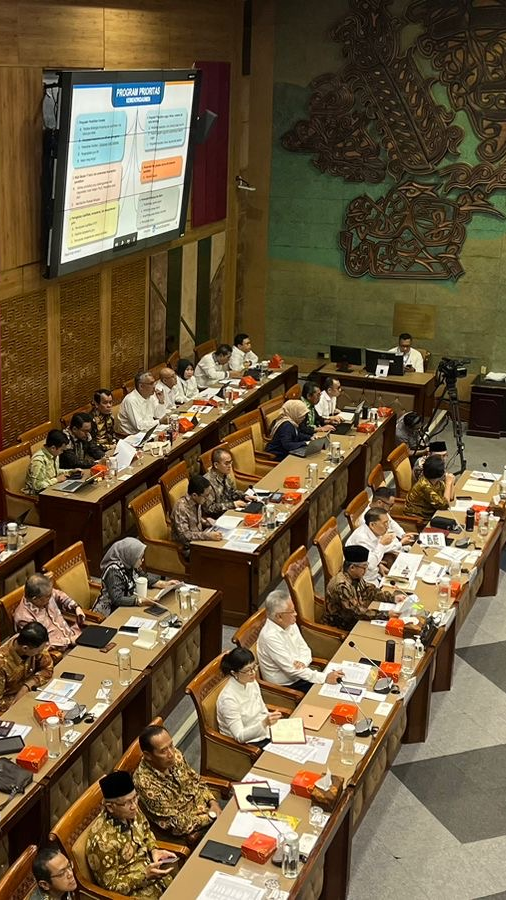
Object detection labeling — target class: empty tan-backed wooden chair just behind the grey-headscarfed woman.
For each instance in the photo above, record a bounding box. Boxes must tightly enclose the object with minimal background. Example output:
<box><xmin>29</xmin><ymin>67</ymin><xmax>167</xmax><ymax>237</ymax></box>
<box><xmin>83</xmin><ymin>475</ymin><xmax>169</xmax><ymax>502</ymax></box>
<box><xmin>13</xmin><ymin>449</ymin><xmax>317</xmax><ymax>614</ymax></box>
<box><xmin>44</xmin><ymin>541</ymin><xmax>103</xmax><ymax>622</ymax></box>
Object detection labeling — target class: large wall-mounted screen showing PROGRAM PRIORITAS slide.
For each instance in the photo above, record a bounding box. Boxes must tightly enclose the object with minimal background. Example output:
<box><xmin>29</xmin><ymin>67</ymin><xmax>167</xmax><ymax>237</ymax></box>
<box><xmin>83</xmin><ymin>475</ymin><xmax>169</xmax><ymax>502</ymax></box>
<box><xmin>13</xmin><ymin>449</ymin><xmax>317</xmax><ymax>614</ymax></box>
<box><xmin>46</xmin><ymin>69</ymin><xmax>201</xmax><ymax>278</ymax></box>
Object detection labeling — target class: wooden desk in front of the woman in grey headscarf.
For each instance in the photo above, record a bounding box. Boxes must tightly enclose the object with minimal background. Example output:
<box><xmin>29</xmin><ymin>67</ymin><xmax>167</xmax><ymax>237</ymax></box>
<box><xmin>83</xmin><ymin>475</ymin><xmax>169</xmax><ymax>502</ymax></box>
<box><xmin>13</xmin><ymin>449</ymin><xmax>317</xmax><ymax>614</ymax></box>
<box><xmin>66</xmin><ymin>588</ymin><xmax>222</xmax><ymax>722</ymax></box>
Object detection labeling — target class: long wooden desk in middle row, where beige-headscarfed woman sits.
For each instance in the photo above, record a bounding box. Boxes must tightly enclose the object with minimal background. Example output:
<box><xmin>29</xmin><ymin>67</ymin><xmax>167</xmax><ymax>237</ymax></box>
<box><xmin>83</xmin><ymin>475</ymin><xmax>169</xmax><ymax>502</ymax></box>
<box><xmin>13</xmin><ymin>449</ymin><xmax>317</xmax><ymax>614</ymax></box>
<box><xmin>190</xmin><ymin>416</ymin><xmax>395</xmax><ymax>625</ymax></box>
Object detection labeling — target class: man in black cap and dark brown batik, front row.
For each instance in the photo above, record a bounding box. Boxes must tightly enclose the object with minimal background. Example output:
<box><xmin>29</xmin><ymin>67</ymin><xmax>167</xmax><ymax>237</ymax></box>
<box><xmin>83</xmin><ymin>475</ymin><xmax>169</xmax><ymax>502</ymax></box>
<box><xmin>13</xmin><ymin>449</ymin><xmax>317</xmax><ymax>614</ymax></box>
<box><xmin>322</xmin><ymin>544</ymin><xmax>404</xmax><ymax>631</ymax></box>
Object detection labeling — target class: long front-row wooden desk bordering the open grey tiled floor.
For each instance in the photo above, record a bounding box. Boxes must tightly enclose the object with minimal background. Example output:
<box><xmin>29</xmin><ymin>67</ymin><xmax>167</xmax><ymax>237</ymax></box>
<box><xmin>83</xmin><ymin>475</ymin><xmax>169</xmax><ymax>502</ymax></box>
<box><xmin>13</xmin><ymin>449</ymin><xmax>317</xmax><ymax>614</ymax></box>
<box><xmin>163</xmin><ymin>475</ymin><xmax>506</xmax><ymax>900</ymax></box>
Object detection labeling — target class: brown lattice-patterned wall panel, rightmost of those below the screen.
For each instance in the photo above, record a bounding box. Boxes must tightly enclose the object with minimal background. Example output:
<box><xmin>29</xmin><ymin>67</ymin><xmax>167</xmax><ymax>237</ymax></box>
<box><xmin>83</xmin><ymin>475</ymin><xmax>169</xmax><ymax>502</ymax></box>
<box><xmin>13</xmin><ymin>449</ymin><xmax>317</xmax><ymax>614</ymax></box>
<box><xmin>111</xmin><ymin>259</ymin><xmax>146</xmax><ymax>389</ymax></box>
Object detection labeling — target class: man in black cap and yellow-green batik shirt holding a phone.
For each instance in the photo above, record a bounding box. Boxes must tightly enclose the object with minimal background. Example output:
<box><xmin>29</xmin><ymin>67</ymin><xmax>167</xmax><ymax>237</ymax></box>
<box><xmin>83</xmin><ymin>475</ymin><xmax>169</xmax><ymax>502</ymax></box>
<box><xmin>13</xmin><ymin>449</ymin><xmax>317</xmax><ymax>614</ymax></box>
<box><xmin>86</xmin><ymin>771</ymin><xmax>177</xmax><ymax>900</ymax></box>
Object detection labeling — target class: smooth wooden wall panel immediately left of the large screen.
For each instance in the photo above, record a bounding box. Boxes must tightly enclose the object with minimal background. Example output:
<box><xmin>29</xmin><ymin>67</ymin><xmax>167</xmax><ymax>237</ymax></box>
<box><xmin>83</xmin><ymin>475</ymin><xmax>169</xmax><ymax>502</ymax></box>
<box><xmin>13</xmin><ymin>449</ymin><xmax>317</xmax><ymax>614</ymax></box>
<box><xmin>0</xmin><ymin>67</ymin><xmax>42</xmax><ymax>270</ymax></box>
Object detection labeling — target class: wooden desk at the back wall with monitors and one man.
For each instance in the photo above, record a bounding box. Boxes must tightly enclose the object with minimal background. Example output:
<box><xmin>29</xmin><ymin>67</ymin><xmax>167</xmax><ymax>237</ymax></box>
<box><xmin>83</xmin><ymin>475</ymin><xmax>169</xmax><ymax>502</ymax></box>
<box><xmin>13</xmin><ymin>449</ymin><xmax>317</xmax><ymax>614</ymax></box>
<box><xmin>318</xmin><ymin>363</ymin><xmax>435</xmax><ymax>416</ymax></box>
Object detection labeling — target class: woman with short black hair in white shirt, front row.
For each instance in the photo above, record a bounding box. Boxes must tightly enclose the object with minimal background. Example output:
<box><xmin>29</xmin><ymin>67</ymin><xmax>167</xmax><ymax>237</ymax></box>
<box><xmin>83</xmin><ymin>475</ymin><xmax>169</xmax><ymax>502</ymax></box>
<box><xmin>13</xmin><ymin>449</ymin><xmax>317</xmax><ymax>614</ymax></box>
<box><xmin>216</xmin><ymin>647</ymin><xmax>281</xmax><ymax>747</ymax></box>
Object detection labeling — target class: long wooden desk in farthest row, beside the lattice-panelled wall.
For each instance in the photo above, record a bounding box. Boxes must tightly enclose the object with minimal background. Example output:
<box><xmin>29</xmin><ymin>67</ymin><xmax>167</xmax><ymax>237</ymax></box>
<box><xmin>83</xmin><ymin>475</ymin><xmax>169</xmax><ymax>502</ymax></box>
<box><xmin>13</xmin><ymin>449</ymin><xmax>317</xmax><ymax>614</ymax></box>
<box><xmin>39</xmin><ymin>366</ymin><xmax>297</xmax><ymax>575</ymax></box>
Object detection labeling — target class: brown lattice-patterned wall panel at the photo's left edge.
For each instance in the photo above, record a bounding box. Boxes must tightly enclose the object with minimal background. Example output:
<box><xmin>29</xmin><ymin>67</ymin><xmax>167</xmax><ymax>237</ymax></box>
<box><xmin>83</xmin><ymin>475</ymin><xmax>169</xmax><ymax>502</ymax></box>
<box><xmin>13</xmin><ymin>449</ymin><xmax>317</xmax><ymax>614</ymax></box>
<box><xmin>0</xmin><ymin>291</ymin><xmax>49</xmax><ymax>447</ymax></box>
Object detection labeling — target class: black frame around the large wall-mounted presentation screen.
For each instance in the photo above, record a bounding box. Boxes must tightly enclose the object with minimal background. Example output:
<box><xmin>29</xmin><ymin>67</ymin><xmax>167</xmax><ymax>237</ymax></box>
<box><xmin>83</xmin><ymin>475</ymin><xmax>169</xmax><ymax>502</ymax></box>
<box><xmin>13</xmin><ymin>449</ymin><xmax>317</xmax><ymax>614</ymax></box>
<box><xmin>45</xmin><ymin>69</ymin><xmax>202</xmax><ymax>278</ymax></box>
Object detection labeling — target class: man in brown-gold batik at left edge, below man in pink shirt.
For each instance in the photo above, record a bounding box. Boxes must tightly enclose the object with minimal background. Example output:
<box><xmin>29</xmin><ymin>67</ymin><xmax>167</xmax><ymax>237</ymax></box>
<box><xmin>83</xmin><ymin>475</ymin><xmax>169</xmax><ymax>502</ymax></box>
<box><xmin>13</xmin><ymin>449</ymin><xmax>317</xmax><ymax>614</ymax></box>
<box><xmin>0</xmin><ymin>622</ymin><xmax>53</xmax><ymax>713</ymax></box>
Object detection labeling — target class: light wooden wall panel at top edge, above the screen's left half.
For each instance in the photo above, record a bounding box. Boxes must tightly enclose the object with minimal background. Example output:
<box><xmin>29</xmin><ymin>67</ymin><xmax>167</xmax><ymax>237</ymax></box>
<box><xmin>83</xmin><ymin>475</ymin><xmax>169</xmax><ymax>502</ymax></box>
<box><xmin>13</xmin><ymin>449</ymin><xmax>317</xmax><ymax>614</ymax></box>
<box><xmin>17</xmin><ymin>0</ymin><xmax>104</xmax><ymax>69</ymax></box>
